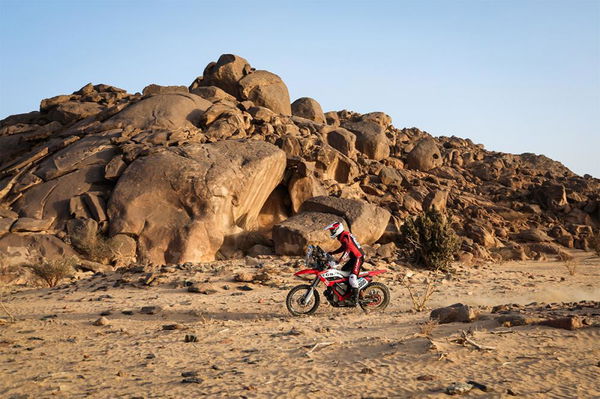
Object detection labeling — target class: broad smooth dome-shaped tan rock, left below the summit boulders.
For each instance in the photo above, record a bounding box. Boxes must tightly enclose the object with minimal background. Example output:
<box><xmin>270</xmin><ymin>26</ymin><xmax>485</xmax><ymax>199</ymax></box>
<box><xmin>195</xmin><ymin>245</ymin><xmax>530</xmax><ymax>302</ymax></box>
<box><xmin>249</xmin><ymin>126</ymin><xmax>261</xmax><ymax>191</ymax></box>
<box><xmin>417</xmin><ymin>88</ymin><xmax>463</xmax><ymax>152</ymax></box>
<box><xmin>104</xmin><ymin>93</ymin><xmax>212</xmax><ymax>130</ymax></box>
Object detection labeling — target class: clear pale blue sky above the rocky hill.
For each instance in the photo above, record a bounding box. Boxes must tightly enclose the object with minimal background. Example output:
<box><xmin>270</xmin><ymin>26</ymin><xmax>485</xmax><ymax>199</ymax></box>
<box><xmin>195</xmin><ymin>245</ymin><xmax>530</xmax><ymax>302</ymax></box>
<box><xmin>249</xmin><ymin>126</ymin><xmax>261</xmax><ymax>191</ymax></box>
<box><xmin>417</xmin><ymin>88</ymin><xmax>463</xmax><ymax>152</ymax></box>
<box><xmin>0</xmin><ymin>0</ymin><xmax>600</xmax><ymax>177</ymax></box>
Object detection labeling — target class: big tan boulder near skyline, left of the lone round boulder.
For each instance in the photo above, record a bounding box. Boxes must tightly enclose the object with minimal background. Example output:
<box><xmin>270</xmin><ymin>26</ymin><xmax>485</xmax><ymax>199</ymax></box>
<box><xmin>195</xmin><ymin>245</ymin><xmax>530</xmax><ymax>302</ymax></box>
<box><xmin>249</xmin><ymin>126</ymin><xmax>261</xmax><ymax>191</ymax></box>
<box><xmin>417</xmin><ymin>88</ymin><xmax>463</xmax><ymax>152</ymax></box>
<box><xmin>342</xmin><ymin>120</ymin><xmax>390</xmax><ymax>161</ymax></box>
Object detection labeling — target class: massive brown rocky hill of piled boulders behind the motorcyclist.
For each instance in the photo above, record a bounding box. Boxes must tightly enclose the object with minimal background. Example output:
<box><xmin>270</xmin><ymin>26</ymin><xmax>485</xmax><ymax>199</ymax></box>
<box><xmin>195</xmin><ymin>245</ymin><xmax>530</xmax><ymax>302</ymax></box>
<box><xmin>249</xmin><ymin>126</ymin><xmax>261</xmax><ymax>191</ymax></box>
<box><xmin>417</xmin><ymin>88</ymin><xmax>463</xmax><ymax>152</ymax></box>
<box><xmin>0</xmin><ymin>54</ymin><xmax>600</xmax><ymax>267</ymax></box>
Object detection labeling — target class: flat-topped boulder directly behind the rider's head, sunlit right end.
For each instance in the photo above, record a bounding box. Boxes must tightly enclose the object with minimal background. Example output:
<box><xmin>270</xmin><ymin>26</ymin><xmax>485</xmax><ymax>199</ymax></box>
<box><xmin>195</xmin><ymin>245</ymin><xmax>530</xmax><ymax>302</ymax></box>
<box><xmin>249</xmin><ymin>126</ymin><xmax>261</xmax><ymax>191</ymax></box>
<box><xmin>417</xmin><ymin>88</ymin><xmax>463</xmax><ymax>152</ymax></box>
<box><xmin>300</xmin><ymin>196</ymin><xmax>391</xmax><ymax>244</ymax></box>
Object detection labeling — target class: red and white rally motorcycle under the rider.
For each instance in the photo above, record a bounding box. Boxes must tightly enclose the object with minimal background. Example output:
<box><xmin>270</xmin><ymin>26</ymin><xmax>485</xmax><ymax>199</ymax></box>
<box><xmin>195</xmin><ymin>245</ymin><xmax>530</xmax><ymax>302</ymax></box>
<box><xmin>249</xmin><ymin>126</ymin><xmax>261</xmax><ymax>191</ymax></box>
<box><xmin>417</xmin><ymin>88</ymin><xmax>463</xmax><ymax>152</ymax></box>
<box><xmin>286</xmin><ymin>245</ymin><xmax>390</xmax><ymax>316</ymax></box>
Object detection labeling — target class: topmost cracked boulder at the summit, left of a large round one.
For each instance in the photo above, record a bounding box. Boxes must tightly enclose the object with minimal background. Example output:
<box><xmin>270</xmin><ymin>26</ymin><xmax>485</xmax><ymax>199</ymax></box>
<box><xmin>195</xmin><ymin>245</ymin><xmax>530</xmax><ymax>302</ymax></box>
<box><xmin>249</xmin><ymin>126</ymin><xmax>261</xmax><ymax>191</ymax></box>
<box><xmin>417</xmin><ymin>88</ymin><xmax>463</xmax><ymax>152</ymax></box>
<box><xmin>199</xmin><ymin>54</ymin><xmax>252</xmax><ymax>97</ymax></box>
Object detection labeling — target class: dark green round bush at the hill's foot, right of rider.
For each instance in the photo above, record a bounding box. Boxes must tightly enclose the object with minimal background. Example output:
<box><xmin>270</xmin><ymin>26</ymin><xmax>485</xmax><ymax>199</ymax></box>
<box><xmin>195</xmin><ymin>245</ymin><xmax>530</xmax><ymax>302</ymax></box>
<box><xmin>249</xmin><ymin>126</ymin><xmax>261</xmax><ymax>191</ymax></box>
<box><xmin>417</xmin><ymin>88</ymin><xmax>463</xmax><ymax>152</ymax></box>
<box><xmin>400</xmin><ymin>210</ymin><xmax>460</xmax><ymax>271</ymax></box>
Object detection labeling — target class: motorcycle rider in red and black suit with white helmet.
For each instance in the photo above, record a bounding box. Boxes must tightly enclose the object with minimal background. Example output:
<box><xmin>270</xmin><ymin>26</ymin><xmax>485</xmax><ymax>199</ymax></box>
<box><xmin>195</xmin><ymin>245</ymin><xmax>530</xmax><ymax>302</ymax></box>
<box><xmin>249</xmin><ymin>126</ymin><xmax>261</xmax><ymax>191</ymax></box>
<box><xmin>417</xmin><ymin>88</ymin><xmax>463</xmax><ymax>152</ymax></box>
<box><xmin>324</xmin><ymin>222</ymin><xmax>365</xmax><ymax>305</ymax></box>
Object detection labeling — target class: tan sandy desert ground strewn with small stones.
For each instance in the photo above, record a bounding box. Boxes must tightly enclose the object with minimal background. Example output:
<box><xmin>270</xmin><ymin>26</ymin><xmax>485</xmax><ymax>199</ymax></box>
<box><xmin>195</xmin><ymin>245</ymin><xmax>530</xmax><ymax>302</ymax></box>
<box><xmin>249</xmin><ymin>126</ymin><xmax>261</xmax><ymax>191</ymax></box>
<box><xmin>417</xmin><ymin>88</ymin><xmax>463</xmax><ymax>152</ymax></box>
<box><xmin>0</xmin><ymin>252</ymin><xmax>600</xmax><ymax>399</ymax></box>
